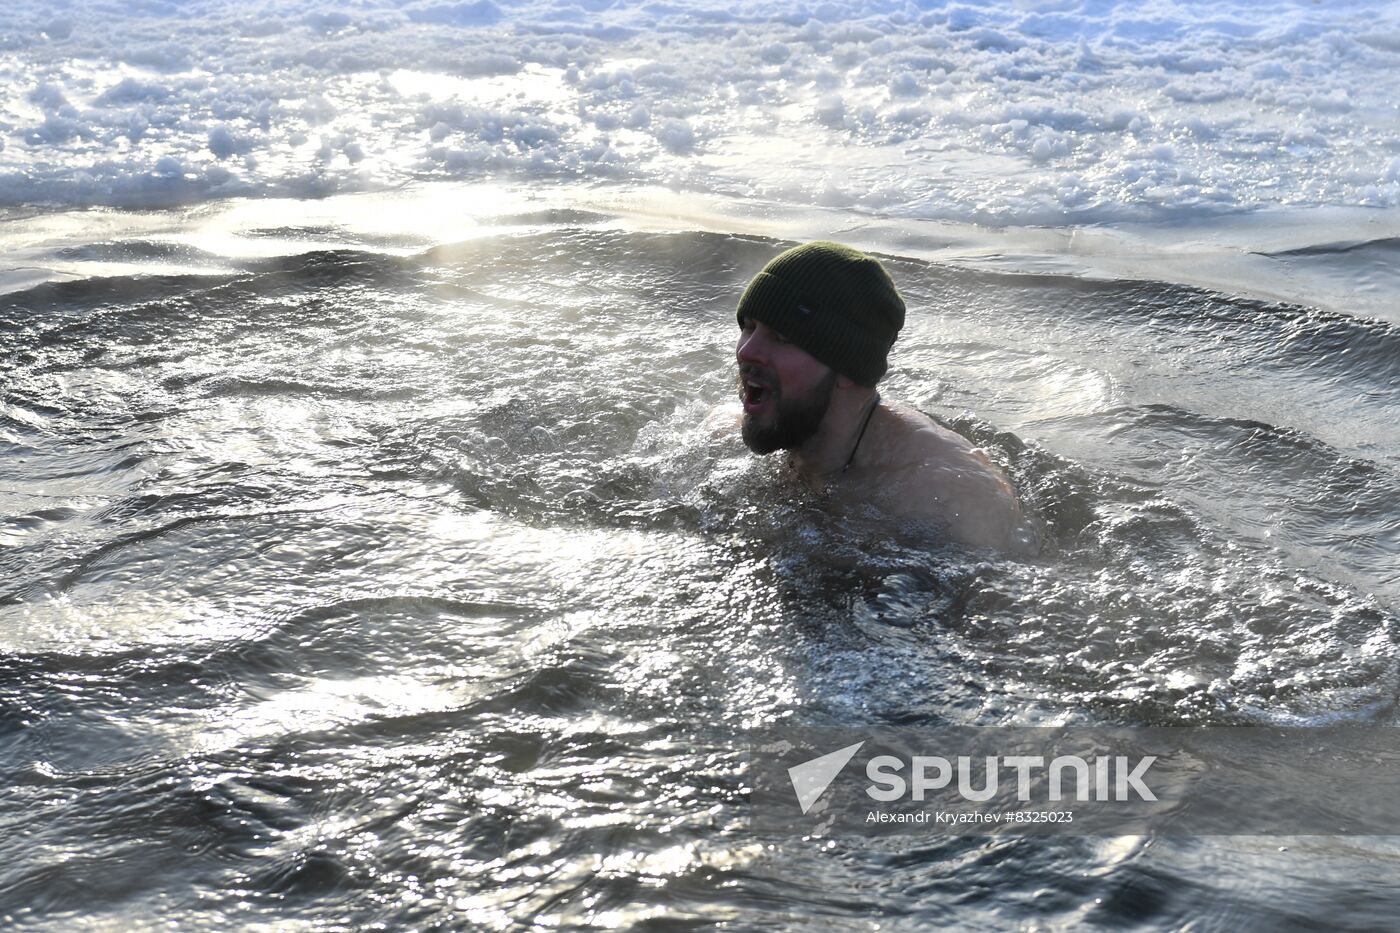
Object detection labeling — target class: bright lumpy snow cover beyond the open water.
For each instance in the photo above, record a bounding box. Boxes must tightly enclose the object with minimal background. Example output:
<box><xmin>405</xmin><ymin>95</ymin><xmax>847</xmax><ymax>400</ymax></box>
<box><xmin>0</xmin><ymin>0</ymin><xmax>1400</xmax><ymax>226</ymax></box>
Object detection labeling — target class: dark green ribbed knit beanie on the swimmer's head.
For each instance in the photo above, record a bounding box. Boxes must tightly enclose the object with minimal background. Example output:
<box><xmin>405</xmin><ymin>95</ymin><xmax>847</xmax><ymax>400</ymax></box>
<box><xmin>738</xmin><ymin>241</ymin><xmax>904</xmax><ymax>385</ymax></box>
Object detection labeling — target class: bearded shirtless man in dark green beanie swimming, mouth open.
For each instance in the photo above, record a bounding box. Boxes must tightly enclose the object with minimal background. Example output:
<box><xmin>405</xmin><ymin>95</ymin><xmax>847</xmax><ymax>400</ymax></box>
<box><xmin>735</xmin><ymin>242</ymin><xmax>1033</xmax><ymax>552</ymax></box>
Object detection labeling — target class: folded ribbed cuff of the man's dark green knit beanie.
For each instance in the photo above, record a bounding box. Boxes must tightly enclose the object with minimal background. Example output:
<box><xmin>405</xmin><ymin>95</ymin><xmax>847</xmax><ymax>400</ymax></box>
<box><xmin>736</xmin><ymin>272</ymin><xmax>893</xmax><ymax>387</ymax></box>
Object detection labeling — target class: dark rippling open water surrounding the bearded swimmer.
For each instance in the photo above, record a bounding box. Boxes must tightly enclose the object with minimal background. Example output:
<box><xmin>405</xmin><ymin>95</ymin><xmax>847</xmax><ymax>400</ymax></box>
<box><xmin>0</xmin><ymin>227</ymin><xmax>1400</xmax><ymax>930</ymax></box>
